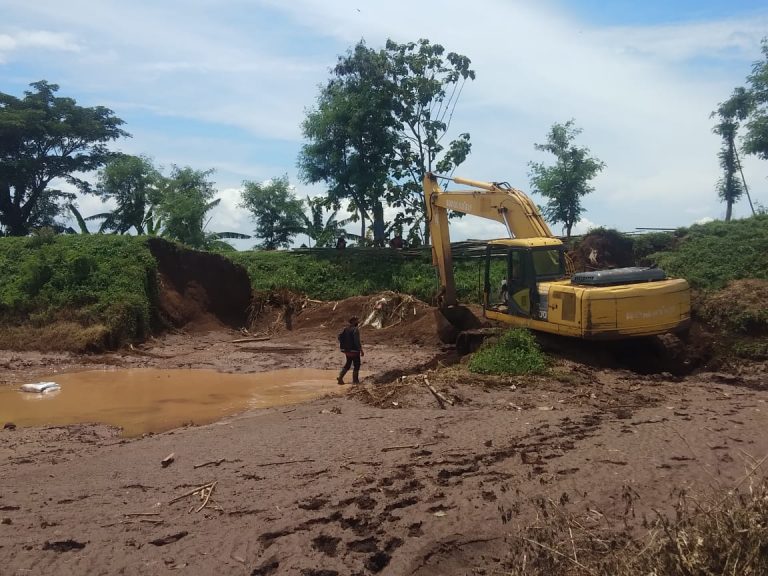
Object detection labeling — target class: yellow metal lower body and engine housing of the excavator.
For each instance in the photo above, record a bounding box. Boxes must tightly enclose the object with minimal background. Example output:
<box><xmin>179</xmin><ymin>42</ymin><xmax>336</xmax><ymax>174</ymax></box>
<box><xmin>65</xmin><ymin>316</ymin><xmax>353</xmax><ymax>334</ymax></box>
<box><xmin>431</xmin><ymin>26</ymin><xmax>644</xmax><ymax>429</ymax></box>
<box><xmin>485</xmin><ymin>279</ymin><xmax>691</xmax><ymax>340</ymax></box>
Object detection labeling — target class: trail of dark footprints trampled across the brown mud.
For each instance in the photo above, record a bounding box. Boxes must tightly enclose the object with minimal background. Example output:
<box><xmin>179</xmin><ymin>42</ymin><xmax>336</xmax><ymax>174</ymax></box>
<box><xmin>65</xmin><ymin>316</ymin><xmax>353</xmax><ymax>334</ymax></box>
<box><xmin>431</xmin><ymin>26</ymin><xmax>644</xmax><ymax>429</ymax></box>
<box><xmin>248</xmin><ymin>414</ymin><xmax>602</xmax><ymax>574</ymax></box>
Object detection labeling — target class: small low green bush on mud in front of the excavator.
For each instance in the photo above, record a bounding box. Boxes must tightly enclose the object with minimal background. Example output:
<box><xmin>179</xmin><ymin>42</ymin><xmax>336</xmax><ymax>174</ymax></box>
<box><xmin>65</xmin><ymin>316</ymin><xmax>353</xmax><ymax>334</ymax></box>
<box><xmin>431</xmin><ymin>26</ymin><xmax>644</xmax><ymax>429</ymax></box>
<box><xmin>468</xmin><ymin>328</ymin><xmax>548</xmax><ymax>374</ymax></box>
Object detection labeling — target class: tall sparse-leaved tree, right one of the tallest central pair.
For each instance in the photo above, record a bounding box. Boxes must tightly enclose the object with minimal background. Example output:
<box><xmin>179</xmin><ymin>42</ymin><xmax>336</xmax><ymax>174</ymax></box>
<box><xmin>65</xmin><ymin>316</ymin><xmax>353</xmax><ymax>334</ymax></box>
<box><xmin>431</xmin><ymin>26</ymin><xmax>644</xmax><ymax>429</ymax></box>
<box><xmin>385</xmin><ymin>39</ymin><xmax>475</xmax><ymax>243</ymax></box>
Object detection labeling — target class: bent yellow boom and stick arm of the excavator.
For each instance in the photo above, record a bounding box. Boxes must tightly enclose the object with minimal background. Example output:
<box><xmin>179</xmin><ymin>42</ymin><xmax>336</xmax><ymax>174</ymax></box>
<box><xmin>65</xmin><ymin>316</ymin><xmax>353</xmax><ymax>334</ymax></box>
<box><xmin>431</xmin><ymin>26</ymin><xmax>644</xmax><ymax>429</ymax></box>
<box><xmin>423</xmin><ymin>172</ymin><xmax>554</xmax><ymax>306</ymax></box>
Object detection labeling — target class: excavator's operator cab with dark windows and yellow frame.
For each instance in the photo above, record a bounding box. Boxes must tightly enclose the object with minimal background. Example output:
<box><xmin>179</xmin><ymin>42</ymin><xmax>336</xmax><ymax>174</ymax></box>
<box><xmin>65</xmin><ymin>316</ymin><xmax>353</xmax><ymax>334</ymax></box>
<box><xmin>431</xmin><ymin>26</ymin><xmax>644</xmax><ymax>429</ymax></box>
<box><xmin>483</xmin><ymin>238</ymin><xmax>565</xmax><ymax>320</ymax></box>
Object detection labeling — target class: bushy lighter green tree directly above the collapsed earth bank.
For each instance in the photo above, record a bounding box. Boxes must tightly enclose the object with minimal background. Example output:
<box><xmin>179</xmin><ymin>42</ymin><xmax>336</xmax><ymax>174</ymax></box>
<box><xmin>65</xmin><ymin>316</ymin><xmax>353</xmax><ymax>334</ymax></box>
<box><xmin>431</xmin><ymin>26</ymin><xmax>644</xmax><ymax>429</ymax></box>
<box><xmin>156</xmin><ymin>166</ymin><xmax>220</xmax><ymax>248</ymax></box>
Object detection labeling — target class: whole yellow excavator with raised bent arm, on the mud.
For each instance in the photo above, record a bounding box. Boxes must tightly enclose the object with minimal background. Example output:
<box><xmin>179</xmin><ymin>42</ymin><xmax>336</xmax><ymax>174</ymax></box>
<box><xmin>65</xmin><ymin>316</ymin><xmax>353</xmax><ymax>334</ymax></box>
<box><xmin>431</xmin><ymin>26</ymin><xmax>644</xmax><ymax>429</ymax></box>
<box><xmin>423</xmin><ymin>173</ymin><xmax>691</xmax><ymax>340</ymax></box>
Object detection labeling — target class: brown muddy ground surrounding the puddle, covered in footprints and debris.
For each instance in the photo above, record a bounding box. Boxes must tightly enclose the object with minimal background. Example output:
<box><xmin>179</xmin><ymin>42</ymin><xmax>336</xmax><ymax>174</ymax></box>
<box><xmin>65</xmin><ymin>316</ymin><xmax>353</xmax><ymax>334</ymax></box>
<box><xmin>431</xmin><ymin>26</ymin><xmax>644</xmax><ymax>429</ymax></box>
<box><xmin>0</xmin><ymin>300</ymin><xmax>768</xmax><ymax>576</ymax></box>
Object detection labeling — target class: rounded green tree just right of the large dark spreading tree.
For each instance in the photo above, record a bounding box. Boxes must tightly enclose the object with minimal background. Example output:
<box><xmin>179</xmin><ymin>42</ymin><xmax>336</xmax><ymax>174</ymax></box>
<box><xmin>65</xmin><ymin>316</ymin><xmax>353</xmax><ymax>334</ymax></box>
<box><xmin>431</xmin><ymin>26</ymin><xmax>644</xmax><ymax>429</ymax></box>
<box><xmin>95</xmin><ymin>154</ymin><xmax>164</xmax><ymax>234</ymax></box>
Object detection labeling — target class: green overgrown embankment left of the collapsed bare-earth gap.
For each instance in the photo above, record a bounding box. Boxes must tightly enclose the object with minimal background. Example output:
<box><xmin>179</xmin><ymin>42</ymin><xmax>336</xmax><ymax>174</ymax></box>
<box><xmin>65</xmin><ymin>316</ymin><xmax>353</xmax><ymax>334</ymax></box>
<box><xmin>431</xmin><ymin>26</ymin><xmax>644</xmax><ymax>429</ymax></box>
<box><xmin>0</xmin><ymin>235</ymin><xmax>157</xmax><ymax>345</ymax></box>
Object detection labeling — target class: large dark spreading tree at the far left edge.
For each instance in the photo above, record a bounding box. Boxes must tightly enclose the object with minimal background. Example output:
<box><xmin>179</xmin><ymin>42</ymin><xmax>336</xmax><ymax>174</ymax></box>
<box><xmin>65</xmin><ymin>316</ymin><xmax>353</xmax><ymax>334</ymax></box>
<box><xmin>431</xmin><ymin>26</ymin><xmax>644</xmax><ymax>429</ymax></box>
<box><xmin>0</xmin><ymin>80</ymin><xmax>128</xmax><ymax>236</ymax></box>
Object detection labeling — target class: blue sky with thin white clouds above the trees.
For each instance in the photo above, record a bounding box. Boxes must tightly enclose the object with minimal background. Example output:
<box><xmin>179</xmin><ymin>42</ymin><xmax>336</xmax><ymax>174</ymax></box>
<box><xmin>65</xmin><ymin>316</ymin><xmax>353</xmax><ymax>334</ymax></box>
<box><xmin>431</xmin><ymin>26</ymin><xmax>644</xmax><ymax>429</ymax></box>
<box><xmin>0</xmin><ymin>0</ymin><xmax>768</xmax><ymax>248</ymax></box>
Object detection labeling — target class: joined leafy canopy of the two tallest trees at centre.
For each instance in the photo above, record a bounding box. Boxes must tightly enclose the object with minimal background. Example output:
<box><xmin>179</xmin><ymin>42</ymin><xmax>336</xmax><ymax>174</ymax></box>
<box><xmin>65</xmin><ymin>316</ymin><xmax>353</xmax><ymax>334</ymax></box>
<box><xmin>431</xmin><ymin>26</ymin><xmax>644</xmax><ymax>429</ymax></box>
<box><xmin>299</xmin><ymin>39</ymin><xmax>475</xmax><ymax>244</ymax></box>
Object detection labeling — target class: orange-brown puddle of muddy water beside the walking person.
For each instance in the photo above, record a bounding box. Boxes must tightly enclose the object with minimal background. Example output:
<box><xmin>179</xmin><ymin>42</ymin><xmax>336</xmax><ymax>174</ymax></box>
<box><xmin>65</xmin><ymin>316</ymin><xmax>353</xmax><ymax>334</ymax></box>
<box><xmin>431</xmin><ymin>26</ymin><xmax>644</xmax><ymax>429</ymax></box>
<box><xmin>0</xmin><ymin>368</ymin><xmax>354</xmax><ymax>436</ymax></box>
